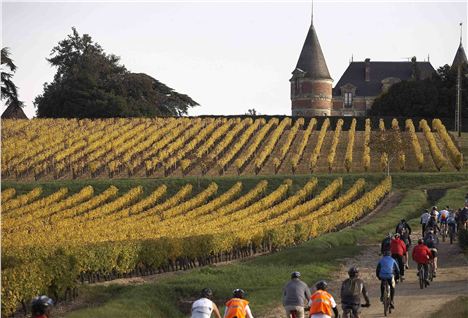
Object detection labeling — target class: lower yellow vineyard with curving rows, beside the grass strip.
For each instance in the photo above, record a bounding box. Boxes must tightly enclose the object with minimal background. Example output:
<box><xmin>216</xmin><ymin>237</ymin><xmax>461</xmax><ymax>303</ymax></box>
<box><xmin>2</xmin><ymin>177</ymin><xmax>391</xmax><ymax>314</ymax></box>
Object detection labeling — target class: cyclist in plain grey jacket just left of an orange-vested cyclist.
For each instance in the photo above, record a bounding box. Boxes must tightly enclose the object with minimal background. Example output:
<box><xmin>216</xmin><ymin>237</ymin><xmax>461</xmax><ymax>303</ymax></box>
<box><xmin>283</xmin><ymin>272</ymin><xmax>311</xmax><ymax>318</ymax></box>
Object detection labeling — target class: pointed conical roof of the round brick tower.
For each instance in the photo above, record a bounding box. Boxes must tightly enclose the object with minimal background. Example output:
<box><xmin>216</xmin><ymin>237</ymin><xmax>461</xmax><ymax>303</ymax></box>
<box><xmin>296</xmin><ymin>24</ymin><xmax>332</xmax><ymax>80</ymax></box>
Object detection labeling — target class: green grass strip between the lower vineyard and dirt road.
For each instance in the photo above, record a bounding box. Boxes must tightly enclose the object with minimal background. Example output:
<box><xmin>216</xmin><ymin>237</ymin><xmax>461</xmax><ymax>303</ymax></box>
<box><xmin>66</xmin><ymin>190</ymin><xmax>427</xmax><ymax>318</ymax></box>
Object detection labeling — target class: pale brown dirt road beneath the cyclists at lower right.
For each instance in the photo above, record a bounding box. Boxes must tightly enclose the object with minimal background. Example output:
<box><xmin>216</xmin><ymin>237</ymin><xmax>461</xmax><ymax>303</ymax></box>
<box><xmin>330</xmin><ymin>236</ymin><xmax>468</xmax><ymax>318</ymax></box>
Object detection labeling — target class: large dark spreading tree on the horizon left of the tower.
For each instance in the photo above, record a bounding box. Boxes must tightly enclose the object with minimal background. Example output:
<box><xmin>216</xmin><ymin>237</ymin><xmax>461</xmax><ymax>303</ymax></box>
<box><xmin>34</xmin><ymin>28</ymin><xmax>198</xmax><ymax>118</ymax></box>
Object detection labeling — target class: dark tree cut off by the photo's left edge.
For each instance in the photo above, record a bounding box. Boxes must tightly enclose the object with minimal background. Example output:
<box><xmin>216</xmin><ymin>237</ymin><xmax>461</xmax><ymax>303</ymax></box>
<box><xmin>1</xmin><ymin>47</ymin><xmax>23</xmax><ymax>107</ymax></box>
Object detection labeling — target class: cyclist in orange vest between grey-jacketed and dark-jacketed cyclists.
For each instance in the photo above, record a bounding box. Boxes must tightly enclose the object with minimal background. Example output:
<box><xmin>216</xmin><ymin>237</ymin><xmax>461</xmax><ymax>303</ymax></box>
<box><xmin>309</xmin><ymin>280</ymin><xmax>340</xmax><ymax>318</ymax></box>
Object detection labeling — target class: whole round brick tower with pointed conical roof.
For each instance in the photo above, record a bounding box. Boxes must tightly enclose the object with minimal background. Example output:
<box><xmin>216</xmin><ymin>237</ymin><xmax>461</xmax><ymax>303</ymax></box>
<box><xmin>289</xmin><ymin>22</ymin><xmax>333</xmax><ymax>116</ymax></box>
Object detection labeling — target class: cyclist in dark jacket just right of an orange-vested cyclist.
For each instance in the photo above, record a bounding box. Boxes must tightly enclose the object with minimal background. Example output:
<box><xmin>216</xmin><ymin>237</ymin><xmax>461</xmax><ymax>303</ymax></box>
<box><xmin>341</xmin><ymin>266</ymin><xmax>370</xmax><ymax>318</ymax></box>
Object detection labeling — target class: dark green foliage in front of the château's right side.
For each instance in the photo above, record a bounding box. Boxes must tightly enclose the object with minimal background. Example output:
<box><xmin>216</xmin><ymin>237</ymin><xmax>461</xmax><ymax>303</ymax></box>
<box><xmin>370</xmin><ymin>65</ymin><xmax>468</xmax><ymax>118</ymax></box>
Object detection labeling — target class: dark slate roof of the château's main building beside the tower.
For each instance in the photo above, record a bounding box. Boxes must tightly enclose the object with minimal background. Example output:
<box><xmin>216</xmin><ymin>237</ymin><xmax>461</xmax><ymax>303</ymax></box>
<box><xmin>333</xmin><ymin>61</ymin><xmax>435</xmax><ymax>96</ymax></box>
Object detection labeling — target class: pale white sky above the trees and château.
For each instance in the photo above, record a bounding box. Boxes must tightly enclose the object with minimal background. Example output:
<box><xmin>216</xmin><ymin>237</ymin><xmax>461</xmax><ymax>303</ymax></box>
<box><xmin>0</xmin><ymin>0</ymin><xmax>468</xmax><ymax>118</ymax></box>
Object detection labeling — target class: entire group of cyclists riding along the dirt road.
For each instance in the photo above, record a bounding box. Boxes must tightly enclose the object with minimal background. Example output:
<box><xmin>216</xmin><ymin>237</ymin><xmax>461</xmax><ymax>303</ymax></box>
<box><xmin>28</xmin><ymin>200</ymin><xmax>468</xmax><ymax>318</ymax></box>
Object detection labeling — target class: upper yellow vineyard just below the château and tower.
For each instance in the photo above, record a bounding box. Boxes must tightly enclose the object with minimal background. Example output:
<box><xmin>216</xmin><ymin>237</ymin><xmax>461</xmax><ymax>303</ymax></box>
<box><xmin>1</xmin><ymin>117</ymin><xmax>463</xmax><ymax>181</ymax></box>
